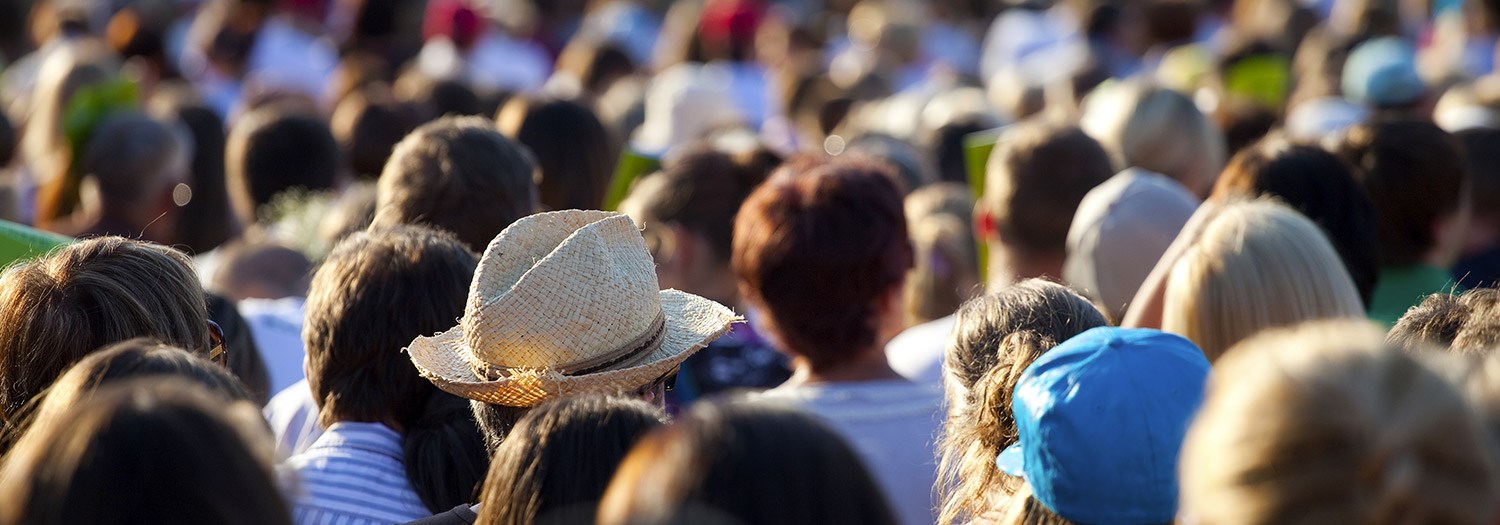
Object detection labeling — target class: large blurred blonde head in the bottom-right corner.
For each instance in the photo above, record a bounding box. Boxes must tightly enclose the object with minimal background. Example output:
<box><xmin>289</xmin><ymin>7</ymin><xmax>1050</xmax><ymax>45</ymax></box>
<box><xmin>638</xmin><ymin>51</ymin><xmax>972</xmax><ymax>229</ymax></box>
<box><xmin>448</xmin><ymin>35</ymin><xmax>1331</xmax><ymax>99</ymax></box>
<box><xmin>1179</xmin><ymin>321</ymin><xmax>1497</xmax><ymax>525</ymax></box>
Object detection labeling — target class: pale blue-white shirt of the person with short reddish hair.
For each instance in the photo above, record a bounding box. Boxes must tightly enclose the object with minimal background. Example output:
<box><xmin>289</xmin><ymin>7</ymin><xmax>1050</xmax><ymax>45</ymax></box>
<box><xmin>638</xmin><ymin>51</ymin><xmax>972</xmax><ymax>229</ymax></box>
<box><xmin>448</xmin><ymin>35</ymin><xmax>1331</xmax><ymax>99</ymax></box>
<box><xmin>752</xmin><ymin>380</ymin><xmax>944</xmax><ymax>525</ymax></box>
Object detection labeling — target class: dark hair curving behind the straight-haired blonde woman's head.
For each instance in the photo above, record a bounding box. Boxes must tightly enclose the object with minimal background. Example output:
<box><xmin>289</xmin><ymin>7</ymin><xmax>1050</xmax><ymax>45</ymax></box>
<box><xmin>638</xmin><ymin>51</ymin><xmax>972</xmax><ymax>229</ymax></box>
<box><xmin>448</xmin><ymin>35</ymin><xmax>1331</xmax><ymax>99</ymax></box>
<box><xmin>1212</xmin><ymin>138</ymin><xmax>1380</xmax><ymax>305</ymax></box>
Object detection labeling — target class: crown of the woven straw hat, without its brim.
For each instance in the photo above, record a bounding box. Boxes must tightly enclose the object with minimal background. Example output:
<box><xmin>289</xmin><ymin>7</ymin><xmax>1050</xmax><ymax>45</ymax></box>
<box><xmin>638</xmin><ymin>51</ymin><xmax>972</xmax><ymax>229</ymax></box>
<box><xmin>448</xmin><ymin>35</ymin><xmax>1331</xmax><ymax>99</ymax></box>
<box><xmin>464</xmin><ymin>212</ymin><xmax>662</xmax><ymax>368</ymax></box>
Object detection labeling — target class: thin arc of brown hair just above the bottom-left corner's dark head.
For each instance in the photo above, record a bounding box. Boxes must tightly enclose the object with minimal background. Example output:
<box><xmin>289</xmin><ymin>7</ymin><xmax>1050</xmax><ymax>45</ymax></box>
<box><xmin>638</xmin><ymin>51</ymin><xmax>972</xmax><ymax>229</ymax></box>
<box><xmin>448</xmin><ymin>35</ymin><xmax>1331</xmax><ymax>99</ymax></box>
<box><xmin>6</xmin><ymin>338</ymin><xmax>254</xmax><ymax>443</ymax></box>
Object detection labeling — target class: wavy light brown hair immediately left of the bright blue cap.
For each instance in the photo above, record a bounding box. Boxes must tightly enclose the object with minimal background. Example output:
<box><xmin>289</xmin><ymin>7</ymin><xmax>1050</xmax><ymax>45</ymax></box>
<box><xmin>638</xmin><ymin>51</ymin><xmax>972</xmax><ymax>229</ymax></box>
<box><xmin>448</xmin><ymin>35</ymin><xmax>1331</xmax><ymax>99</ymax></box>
<box><xmin>938</xmin><ymin>279</ymin><xmax>1109</xmax><ymax>524</ymax></box>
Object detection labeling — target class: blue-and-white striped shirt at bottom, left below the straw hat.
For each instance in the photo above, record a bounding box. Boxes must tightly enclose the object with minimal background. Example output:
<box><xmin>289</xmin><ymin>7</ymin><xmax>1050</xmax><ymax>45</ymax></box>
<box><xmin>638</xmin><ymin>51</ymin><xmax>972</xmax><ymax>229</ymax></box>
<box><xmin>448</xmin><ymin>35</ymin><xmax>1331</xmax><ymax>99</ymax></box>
<box><xmin>281</xmin><ymin>422</ymin><xmax>432</xmax><ymax>525</ymax></box>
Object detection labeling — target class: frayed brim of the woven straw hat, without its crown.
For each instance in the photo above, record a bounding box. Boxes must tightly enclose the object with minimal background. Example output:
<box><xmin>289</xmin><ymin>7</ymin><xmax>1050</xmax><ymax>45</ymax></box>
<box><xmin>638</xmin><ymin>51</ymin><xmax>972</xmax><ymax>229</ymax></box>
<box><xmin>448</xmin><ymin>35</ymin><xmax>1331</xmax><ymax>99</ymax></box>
<box><xmin>407</xmin><ymin>290</ymin><xmax>744</xmax><ymax>407</ymax></box>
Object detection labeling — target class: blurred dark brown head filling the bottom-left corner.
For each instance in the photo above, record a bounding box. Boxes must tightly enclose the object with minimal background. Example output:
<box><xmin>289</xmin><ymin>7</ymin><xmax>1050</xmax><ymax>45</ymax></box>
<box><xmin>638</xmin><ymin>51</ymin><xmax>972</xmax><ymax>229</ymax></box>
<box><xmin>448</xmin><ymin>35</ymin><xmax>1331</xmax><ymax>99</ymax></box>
<box><xmin>0</xmin><ymin>380</ymin><xmax>291</xmax><ymax>525</ymax></box>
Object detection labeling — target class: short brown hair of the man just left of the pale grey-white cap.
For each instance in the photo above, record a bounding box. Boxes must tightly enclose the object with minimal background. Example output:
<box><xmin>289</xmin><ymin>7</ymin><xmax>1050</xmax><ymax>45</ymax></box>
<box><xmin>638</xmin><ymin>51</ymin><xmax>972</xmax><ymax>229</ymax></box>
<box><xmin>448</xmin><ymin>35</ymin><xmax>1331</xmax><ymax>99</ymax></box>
<box><xmin>980</xmin><ymin>120</ymin><xmax>1115</xmax><ymax>255</ymax></box>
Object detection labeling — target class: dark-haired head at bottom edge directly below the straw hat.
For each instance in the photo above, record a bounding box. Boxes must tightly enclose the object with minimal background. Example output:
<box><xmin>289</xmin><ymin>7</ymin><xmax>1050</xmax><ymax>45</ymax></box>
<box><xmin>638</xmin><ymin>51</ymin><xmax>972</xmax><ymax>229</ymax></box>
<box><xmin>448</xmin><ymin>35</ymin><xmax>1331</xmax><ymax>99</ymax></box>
<box><xmin>479</xmin><ymin>395</ymin><xmax>665</xmax><ymax>525</ymax></box>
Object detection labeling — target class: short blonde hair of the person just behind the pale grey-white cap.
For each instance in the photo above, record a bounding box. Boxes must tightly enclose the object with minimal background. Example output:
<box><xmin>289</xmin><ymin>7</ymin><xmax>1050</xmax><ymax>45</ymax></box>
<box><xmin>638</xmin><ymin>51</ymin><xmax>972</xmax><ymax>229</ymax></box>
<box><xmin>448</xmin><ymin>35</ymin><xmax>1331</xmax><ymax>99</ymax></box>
<box><xmin>1082</xmin><ymin>81</ymin><xmax>1227</xmax><ymax>198</ymax></box>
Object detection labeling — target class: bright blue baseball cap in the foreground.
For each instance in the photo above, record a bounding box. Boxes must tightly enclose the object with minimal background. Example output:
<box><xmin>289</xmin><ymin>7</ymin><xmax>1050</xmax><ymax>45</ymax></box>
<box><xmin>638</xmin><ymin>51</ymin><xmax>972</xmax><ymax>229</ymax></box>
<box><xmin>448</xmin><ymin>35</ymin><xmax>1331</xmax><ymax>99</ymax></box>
<box><xmin>995</xmin><ymin>327</ymin><xmax>1209</xmax><ymax>525</ymax></box>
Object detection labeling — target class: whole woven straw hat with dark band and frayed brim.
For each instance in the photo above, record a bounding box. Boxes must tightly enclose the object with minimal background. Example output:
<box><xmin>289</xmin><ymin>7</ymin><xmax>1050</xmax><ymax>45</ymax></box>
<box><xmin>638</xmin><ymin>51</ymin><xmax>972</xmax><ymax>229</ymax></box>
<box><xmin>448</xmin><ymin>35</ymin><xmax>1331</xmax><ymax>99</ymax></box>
<box><xmin>408</xmin><ymin>210</ymin><xmax>743</xmax><ymax>407</ymax></box>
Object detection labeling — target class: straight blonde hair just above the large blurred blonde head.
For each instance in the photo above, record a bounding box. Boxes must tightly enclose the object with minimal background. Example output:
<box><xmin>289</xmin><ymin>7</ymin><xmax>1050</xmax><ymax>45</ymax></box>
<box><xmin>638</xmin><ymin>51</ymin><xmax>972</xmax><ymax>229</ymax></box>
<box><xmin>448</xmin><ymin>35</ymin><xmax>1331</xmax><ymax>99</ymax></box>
<box><xmin>1161</xmin><ymin>200</ymin><xmax>1365</xmax><ymax>362</ymax></box>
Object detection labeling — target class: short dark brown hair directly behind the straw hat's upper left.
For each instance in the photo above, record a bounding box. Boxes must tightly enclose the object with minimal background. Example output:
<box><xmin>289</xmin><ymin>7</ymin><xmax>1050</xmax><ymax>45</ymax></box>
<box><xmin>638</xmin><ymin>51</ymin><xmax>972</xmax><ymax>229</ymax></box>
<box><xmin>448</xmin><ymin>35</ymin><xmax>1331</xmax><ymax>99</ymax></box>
<box><xmin>374</xmin><ymin>117</ymin><xmax>537</xmax><ymax>252</ymax></box>
